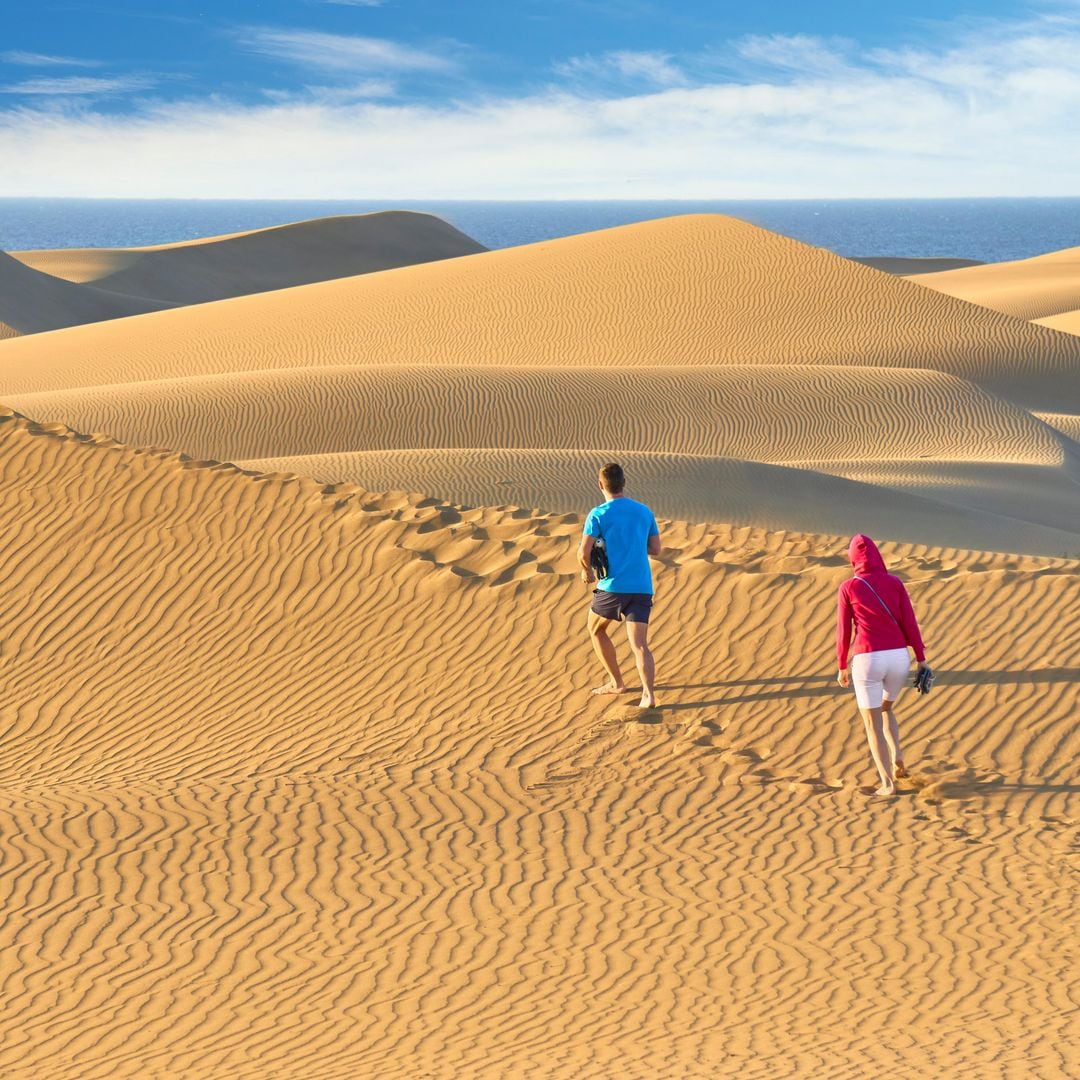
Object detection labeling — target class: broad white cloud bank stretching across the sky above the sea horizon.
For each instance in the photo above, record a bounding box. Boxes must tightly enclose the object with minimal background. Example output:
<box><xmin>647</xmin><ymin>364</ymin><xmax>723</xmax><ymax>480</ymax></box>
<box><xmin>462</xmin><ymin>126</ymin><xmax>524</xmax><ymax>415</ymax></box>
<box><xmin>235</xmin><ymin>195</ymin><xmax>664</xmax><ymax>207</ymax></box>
<box><xmin>0</xmin><ymin>14</ymin><xmax>1080</xmax><ymax>200</ymax></box>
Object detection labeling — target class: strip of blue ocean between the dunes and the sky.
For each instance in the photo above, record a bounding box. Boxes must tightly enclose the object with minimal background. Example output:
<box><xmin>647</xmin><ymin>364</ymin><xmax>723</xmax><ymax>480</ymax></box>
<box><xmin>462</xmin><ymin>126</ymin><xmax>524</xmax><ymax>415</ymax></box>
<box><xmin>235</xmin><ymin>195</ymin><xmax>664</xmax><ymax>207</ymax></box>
<box><xmin>0</xmin><ymin>198</ymin><xmax>1080</xmax><ymax>262</ymax></box>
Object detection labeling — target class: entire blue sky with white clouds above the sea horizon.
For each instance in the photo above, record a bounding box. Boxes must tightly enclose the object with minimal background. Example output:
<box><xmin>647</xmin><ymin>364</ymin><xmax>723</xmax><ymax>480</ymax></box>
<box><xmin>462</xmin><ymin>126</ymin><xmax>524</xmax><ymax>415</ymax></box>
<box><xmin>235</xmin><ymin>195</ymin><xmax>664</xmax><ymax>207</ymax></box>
<box><xmin>0</xmin><ymin>0</ymin><xmax>1080</xmax><ymax>199</ymax></box>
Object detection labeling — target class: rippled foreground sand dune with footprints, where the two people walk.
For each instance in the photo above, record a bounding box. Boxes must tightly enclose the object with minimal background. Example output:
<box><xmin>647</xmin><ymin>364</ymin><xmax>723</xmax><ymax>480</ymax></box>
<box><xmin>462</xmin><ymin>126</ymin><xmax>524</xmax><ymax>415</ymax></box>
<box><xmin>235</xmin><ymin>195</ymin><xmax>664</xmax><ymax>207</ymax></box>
<box><xmin>0</xmin><ymin>416</ymin><xmax>1080</xmax><ymax>1080</ymax></box>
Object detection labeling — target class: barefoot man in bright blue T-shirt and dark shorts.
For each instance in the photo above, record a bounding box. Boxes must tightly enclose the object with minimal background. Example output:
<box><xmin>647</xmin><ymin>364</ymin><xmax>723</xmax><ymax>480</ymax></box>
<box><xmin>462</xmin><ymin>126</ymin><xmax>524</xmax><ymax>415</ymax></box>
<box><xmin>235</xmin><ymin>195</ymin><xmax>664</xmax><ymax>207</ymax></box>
<box><xmin>578</xmin><ymin>464</ymin><xmax>660</xmax><ymax>708</ymax></box>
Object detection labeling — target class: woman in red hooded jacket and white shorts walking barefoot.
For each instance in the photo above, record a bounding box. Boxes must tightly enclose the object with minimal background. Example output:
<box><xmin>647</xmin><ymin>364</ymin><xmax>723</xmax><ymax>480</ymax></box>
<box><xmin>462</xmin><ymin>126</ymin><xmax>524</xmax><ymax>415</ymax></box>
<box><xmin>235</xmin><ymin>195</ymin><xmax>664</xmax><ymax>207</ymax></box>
<box><xmin>836</xmin><ymin>534</ymin><xmax>929</xmax><ymax>795</ymax></box>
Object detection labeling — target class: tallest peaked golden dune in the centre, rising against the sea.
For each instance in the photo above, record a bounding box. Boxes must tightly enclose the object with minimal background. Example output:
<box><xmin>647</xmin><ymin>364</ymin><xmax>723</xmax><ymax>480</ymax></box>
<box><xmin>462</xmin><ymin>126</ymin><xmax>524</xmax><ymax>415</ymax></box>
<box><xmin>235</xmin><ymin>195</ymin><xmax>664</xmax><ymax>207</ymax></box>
<box><xmin>0</xmin><ymin>215</ymin><xmax>1080</xmax><ymax>413</ymax></box>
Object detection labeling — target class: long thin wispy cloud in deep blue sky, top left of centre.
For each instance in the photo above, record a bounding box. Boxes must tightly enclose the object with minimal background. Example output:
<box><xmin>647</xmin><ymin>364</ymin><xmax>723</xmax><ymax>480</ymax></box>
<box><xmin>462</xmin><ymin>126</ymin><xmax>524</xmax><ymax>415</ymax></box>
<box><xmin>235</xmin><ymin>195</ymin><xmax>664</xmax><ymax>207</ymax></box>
<box><xmin>238</xmin><ymin>26</ymin><xmax>455</xmax><ymax>71</ymax></box>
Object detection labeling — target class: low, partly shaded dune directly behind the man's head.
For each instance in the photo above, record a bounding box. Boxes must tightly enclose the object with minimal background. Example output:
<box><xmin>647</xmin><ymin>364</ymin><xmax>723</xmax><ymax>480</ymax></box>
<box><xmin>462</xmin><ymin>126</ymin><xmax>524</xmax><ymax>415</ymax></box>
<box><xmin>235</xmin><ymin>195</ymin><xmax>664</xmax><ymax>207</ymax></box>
<box><xmin>238</xmin><ymin>448</ymin><xmax>1080</xmax><ymax>554</ymax></box>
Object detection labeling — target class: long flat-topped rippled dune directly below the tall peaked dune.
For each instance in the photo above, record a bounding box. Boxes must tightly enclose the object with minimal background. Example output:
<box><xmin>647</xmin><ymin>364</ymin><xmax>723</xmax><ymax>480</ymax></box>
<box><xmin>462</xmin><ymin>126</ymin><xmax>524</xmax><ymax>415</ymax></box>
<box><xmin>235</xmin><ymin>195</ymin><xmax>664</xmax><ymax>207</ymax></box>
<box><xmin>5</xmin><ymin>365</ymin><xmax>1070</xmax><ymax>465</ymax></box>
